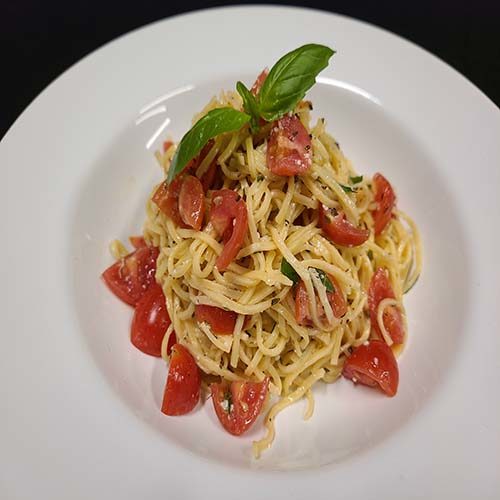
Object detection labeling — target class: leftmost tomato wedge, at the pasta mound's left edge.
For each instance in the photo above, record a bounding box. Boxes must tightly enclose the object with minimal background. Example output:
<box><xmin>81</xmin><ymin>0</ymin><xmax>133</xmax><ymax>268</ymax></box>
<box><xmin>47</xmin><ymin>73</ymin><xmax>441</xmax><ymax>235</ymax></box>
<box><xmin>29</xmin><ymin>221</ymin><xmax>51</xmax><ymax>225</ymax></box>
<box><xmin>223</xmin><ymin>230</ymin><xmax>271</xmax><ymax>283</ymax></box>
<box><xmin>102</xmin><ymin>247</ymin><xmax>159</xmax><ymax>306</ymax></box>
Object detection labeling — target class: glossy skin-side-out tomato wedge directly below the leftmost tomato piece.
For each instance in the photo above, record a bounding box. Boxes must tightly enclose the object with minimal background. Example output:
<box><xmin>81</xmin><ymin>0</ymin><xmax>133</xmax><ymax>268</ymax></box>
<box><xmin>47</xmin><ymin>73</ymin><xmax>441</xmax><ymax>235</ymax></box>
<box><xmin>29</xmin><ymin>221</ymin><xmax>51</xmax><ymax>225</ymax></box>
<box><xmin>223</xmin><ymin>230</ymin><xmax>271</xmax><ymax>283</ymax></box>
<box><xmin>130</xmin><ymin>283</ymin><xmax>170</xmax><ymax>357</ymax></box>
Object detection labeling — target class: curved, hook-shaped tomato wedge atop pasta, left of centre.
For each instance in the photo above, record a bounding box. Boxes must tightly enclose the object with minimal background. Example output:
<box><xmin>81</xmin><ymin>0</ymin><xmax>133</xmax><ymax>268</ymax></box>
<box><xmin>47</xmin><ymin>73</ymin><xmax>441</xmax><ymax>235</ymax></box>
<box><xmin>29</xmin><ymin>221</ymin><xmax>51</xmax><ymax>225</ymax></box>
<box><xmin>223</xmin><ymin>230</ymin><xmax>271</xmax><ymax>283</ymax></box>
<box><xmin>210</xmin><ymin>189</ymin><xmax>248</xmax><ymax>273</ymax></box>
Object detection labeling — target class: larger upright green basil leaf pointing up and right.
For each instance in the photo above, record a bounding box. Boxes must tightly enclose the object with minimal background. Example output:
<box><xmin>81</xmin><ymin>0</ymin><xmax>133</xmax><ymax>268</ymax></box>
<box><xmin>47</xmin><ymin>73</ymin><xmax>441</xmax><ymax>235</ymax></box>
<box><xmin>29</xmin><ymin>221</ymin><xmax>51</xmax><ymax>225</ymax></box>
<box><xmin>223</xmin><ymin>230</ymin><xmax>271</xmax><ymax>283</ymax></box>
<box><xmin>259</xmin><ymin>44</ymin><xmax>335</xmax><ymax>121</ymax></box>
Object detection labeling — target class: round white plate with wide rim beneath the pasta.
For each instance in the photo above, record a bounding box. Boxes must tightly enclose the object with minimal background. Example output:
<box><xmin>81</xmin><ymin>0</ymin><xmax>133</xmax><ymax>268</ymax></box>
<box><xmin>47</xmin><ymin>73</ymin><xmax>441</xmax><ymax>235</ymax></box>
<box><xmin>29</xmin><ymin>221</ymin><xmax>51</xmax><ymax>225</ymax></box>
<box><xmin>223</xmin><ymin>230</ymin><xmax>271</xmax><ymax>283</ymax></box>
<box><xmin>0</xmin><ymin>7</ymin><xmax>500</xmax><ymax>500</ymax></box>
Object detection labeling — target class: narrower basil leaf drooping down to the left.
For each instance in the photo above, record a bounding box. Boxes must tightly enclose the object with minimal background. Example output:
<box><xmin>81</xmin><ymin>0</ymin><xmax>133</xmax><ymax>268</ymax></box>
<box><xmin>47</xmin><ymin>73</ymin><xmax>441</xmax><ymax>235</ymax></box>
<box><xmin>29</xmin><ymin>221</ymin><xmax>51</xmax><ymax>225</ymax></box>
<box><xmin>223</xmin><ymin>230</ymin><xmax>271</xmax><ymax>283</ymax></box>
<box><xmin>167</xmin><ymin>108</ymin><xmax>250</xmax><ymax>184</ymax></box>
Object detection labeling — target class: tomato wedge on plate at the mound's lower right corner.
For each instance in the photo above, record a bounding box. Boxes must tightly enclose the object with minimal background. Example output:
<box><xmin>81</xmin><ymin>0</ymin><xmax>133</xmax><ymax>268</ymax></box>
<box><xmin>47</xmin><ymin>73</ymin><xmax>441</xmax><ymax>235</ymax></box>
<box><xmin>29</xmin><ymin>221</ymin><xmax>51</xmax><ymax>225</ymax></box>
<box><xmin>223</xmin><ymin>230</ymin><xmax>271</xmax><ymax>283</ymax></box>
<box><xmin>342</xmin><ymin>340</ymin><xmax>399</xmax><ymax>397</ymax></box>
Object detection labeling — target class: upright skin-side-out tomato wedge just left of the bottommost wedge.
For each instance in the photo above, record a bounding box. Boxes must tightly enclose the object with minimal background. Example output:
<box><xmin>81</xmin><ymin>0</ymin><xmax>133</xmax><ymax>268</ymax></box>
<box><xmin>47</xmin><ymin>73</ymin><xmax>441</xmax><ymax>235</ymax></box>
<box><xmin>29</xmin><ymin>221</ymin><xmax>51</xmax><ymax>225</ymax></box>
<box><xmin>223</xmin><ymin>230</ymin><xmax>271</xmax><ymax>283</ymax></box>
<box><xmin>161</xmin><ymin>344</ymin><xmax>201</xmax><ymax>416</ymax></box>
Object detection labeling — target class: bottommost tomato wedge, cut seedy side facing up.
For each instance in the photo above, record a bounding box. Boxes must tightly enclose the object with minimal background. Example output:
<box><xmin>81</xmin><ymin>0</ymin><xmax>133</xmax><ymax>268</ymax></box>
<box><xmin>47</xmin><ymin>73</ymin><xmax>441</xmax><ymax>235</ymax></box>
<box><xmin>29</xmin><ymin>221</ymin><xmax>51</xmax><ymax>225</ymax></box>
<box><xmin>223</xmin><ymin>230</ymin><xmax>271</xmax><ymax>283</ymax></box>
<box><xmin>210</xmin><ymin>378</ymin><xmax>269</xmax><ymax>436</ymax></box>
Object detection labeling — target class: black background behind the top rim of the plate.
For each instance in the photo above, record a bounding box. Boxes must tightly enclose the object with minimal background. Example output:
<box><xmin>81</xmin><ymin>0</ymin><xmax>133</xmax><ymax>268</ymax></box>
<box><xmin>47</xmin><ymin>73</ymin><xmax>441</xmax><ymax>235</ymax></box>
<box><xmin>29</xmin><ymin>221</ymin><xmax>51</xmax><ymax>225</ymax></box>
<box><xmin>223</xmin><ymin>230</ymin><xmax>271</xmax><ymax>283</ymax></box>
<box><xmin>0</xmin><ymin>0</ymin><xmax>500</xmax><ymax>137</ymax></box>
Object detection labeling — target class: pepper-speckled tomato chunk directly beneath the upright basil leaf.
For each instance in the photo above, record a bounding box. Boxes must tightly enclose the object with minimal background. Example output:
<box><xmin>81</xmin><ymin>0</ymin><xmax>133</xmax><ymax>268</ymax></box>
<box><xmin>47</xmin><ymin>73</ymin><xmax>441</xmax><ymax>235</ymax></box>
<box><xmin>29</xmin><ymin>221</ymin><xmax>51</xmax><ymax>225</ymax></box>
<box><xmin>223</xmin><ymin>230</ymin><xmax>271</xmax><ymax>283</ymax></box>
<box><xmin>267</xmin><ymin>115</ymin><xmax>312</xmax><ymax>176</ymax></box>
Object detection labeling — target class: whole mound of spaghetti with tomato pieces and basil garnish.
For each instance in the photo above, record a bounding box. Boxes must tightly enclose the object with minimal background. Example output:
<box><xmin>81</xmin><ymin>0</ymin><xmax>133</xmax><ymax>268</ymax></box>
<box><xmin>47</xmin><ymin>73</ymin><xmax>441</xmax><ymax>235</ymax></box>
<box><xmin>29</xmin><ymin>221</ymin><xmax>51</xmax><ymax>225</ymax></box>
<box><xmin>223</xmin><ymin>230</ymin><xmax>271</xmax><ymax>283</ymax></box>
<box><xmin>103</xmin><ymin>44</ymin><xmax>422</xmax><ymax>457</ymax></box>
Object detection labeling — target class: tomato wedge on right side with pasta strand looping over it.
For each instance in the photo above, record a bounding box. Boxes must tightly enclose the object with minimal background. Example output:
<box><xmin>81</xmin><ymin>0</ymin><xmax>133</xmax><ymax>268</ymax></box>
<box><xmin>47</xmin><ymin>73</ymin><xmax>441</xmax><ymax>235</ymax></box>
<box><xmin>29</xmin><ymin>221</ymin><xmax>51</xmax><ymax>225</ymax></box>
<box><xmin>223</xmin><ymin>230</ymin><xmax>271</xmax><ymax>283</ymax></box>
<box><xmin>368</xmin><ymin>267</ymin><xmax>405</xmax><ymax>344</ymax></box>
